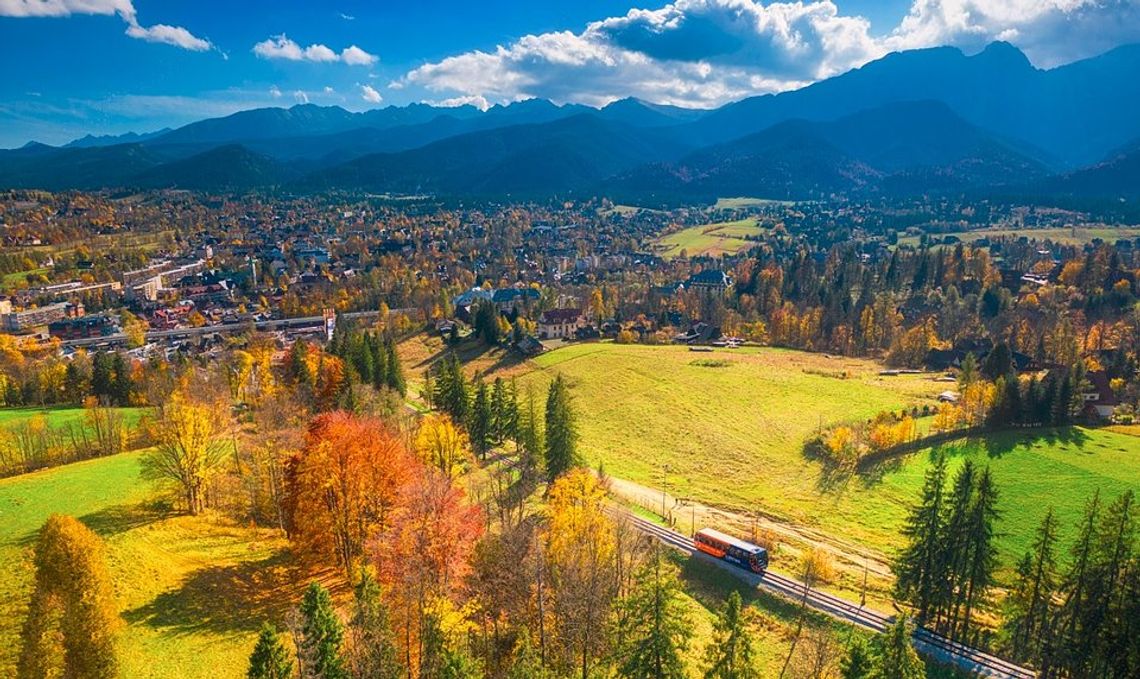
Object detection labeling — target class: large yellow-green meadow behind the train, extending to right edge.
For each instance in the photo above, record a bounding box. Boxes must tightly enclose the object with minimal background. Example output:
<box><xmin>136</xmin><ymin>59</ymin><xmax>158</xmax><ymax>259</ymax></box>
<box><xmin>515</xmin><ymin>343</ymin><xmax>1140</xmax><ymax>578</ymax></box>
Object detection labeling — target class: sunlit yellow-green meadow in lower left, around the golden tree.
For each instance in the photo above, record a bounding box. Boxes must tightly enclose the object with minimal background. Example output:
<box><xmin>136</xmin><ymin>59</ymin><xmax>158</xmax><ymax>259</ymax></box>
<box><xmin>0</xmin><ymin>452</ymin><xmax>307</xmax><ymax>679</ymax></box>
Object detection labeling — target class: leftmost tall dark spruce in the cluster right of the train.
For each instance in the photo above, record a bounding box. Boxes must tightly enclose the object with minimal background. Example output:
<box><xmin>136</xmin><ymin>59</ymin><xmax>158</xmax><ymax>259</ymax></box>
<box><xmin>894</xmin><ymin>453</ymin><xmax>946</xmax><ymax>622</ymax></box>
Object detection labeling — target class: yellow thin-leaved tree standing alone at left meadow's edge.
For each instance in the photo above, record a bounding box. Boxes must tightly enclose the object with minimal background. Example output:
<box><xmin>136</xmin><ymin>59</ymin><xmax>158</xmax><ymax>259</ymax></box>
<box><xmin>143</xmin><ymin>385</ymin><xmax>231</xmax><ymax>514</ymax></box>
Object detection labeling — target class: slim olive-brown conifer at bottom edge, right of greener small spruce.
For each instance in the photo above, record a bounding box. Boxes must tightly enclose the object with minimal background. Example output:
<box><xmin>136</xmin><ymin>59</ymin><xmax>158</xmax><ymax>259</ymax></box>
<box><xmin>349</xmin><ymin>571</ymin><xmax>404</xmax><ymax>679</ymax></box>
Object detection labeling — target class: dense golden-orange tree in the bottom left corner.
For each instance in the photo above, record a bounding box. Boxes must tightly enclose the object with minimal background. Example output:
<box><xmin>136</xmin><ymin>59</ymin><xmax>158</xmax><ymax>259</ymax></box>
<box><xmin>16</xmin><ymin>514</ymin><xmax>122</xmax><ymax>679</ymax></box>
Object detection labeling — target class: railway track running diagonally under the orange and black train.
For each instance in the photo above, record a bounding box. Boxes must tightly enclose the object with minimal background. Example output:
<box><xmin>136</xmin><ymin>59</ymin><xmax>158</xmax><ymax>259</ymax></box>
<box><xmin>628</xmin><ymin>514</ymin><xmax>1036</xmax><ymax>679</ymax></box>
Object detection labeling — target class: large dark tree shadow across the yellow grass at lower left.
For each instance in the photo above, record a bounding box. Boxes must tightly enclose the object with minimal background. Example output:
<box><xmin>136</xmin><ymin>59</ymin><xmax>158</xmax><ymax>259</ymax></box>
<box><xmin>123</xmin><ymin>550</ymin><xmax>340</xmax><ymax>635</ymax></box>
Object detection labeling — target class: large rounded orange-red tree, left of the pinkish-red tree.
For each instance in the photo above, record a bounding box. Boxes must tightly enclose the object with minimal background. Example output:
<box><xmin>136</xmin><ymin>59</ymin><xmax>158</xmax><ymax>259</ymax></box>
<box><xmin>288</xmin><ymin>411</ymin><xmax>417</xmax><ymax>575</ymax></box>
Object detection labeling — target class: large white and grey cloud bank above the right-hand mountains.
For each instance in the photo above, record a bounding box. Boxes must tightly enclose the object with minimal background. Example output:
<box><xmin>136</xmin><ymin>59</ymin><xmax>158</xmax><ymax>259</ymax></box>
<box><xmin>399</xmin><ymin>0</ymin><xmax>1140</xmax><ymax>107</ymax></box>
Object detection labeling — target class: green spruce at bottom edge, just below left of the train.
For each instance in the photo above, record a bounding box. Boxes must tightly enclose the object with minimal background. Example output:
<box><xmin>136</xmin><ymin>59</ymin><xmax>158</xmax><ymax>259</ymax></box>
<box><xmin>618</xmin><ymin>546</ymin><xmax>692</xmax><ymax>679</ymax></box>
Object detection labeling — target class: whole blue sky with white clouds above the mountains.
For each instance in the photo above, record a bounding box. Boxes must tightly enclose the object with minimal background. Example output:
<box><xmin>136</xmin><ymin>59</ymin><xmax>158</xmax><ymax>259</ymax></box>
<box><xmin>0</xmin><ymin>0</ymin><xmax>1140</xmax><ymax>147</ymax></box>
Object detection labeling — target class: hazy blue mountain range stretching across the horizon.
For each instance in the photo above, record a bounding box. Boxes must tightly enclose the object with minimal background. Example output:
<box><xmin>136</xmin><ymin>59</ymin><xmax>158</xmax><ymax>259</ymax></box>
<box><xmin>0</xmin><ymin>42</ymin><xmax>1140</xmax><ymax>201</ymax></box>
